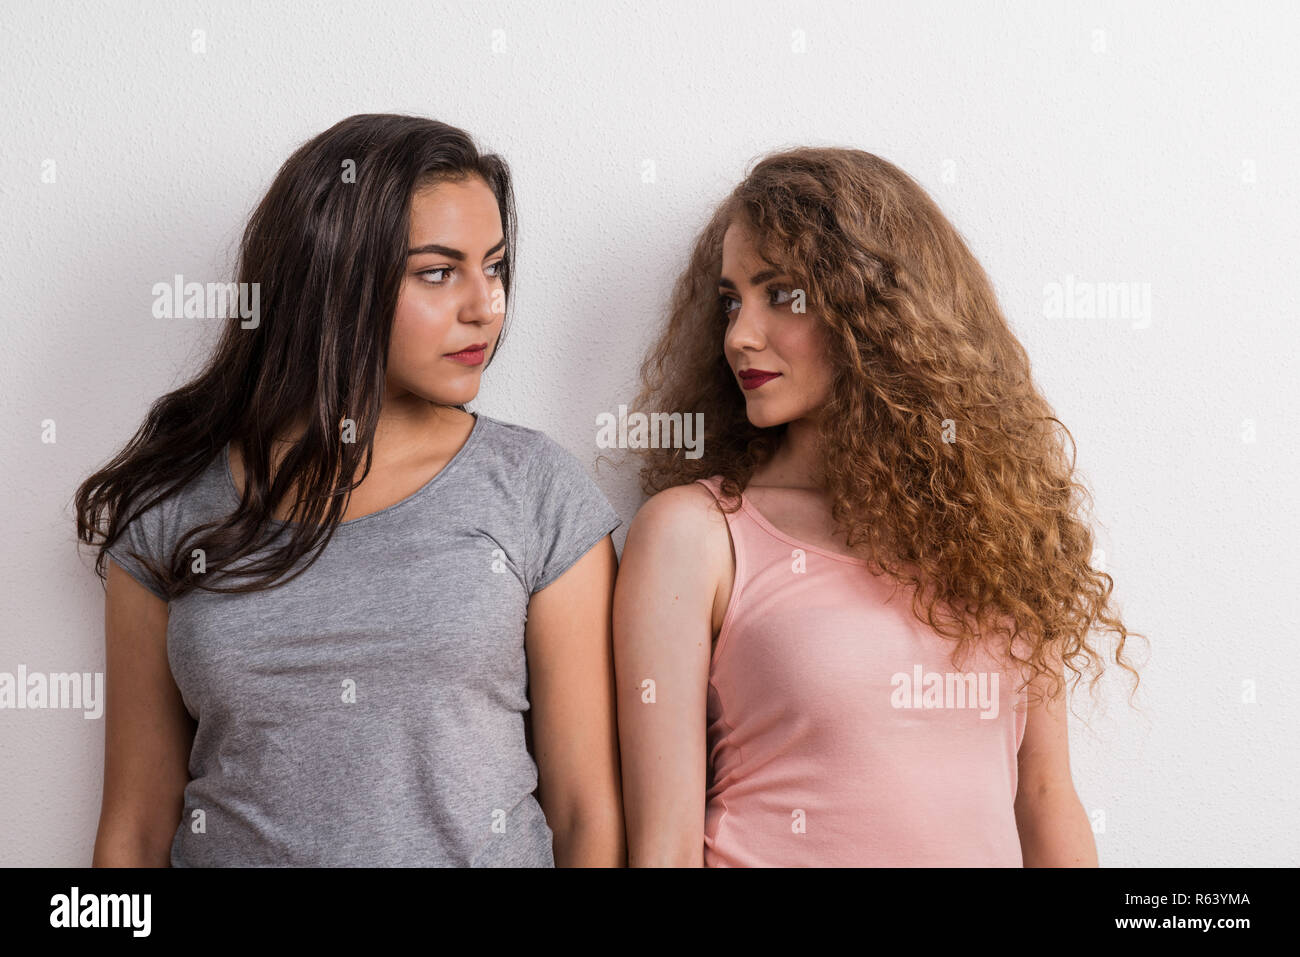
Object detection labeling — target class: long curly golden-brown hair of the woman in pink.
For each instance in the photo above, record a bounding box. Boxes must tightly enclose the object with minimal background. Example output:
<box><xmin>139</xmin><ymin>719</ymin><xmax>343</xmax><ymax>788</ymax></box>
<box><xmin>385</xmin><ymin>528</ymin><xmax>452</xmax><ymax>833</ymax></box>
<box><xmin>633</xmin><ymin>148</ymin><xmax>1143</xmax><ymax>697</ymax></box>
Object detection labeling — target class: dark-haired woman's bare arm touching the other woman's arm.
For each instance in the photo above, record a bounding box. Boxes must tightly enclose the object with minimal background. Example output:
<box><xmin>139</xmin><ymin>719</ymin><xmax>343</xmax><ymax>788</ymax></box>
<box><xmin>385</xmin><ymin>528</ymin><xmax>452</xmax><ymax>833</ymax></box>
<box><xmin>524</xmin><ymin>536</ymin><xmax>627</xmax><ymax>867</ymax></box>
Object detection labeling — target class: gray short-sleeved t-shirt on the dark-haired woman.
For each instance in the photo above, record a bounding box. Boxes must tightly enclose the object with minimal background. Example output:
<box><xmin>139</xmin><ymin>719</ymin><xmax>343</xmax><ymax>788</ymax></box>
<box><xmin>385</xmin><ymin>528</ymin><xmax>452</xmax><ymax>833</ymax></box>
<box><xmin>109</xmin><ymin>413</ymin><xmax>621</xmax><ymax>867</ymax></box>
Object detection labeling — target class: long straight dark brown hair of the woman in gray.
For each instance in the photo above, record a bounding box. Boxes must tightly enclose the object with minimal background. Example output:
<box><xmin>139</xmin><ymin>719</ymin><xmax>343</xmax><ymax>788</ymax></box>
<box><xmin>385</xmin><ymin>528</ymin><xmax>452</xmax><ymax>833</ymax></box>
<box><xmin>75</xmin><ymin>113</ymin><xmax>516</xmax><ymax>599</ymax></box>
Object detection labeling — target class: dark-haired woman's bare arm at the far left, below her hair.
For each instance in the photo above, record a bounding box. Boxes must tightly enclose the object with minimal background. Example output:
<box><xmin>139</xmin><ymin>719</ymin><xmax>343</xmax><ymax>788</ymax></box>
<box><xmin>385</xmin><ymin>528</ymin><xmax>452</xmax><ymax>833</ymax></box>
<box><xmin>92</xmin><ymin>559</ymin><xmax>194</xmax><ymax>867</ymax></box>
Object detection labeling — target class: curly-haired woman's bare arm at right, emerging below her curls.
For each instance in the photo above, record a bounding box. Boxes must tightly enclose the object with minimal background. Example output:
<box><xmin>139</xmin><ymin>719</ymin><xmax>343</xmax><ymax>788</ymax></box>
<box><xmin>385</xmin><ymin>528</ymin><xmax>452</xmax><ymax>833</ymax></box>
<box><xmin>1015</xmin><ymin>657</ymin><xmax>1097</xmax><ymax>867</ymax></box>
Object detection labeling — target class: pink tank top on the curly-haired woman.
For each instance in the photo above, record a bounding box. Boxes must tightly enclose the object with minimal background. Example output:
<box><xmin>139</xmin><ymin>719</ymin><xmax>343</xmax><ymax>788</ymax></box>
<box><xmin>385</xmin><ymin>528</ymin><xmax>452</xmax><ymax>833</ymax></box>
<box><xmin>698</xmin><ymin>476</ymin><xmax>1026</xmax><ymax>867</ymax></box>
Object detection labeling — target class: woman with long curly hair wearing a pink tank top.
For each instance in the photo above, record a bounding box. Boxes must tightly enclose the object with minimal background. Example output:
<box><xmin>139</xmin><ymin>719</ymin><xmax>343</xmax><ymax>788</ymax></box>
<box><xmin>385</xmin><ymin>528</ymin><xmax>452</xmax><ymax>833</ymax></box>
<box><xmin>615</xmin><ymin>148</ymin><xmax>1136</xmax><ymax>867</ymax></box>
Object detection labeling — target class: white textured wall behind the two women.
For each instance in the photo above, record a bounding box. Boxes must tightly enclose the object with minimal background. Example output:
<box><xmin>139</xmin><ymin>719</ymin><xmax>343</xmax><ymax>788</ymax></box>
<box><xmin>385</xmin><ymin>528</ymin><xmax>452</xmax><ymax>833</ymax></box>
<box><xmin>0</xmin><ymin>0</ymin><xmax>1300</xmax><ymax>866</ymax></box>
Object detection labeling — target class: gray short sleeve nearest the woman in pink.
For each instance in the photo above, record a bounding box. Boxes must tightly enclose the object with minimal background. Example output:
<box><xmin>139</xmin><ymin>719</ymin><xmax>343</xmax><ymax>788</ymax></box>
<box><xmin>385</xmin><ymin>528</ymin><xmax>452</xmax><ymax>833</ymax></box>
<box><xmin>525</xmin><ymin>434</ymin><xmax>623</xmax><ymax>594</ymax></box>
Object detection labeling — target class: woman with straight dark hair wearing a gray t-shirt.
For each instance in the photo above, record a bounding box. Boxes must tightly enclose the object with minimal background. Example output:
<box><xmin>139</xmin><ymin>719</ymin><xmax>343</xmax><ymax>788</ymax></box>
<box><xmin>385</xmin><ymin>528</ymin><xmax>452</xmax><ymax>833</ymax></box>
<box><xmin>77</xmin><ymin>114</ymin><xmax>625</xmax><ymax>867</ymax></box>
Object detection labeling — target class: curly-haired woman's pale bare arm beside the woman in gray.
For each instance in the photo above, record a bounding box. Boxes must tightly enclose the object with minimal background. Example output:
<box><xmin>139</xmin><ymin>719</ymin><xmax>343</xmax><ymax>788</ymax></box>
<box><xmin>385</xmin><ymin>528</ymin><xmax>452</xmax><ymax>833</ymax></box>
<box><xmin>614</xmin><ymin>485</ymin><xmax>731</xmax><ymax>867</ymax></box>
